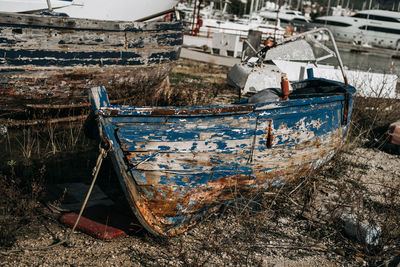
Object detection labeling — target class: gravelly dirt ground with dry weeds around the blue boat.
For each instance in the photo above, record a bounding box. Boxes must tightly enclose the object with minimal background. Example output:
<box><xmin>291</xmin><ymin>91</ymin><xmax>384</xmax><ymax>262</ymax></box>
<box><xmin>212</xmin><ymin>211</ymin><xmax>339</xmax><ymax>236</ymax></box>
<box><xmin>0</xmin><ymin>59</ymin><xmax>400</xmax><ymax>266</ymax></box>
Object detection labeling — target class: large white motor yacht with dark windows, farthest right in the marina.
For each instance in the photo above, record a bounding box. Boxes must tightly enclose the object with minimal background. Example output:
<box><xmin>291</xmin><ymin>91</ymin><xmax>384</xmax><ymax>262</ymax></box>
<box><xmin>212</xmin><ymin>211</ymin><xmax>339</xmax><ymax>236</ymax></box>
<box><xmin>313</xmin><ymin>10</ymin><xmax>400</xmax><ymax>50</ymax></box>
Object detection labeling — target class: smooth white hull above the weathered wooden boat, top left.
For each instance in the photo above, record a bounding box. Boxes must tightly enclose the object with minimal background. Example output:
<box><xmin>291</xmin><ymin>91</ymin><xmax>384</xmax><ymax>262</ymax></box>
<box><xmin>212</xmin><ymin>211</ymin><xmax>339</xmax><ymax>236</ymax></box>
<box><xmin>0</xmin><ymin>0</ymin><xmax>178</xmax><ymax>21</ymax></box>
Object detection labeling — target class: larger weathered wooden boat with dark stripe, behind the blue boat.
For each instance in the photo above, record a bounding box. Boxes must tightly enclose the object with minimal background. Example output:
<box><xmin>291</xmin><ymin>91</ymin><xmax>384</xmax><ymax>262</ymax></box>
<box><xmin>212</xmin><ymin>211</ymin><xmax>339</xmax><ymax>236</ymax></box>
<box><xmin>0</xmin><ymin>12</ymin><xmax>183</xmax><ymax>124</ymax></box>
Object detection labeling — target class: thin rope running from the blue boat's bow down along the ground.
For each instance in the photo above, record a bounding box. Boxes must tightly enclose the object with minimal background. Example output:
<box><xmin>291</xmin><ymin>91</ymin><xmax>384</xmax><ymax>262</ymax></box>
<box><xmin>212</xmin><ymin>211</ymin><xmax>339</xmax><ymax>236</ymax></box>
<box><xmin>0</xmin><ymin>142</ymin><xmax>112</xmax><ymax>256</ymax></box>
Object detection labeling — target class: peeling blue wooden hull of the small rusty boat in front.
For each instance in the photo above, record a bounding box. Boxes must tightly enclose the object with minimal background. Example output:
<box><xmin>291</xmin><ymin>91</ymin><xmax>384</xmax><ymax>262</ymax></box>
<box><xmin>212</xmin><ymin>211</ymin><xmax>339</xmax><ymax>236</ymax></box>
<box><xmin>91</xmin><ymin>79</ymin><xmax>355</xmax><ymax>236</ymax></box>
